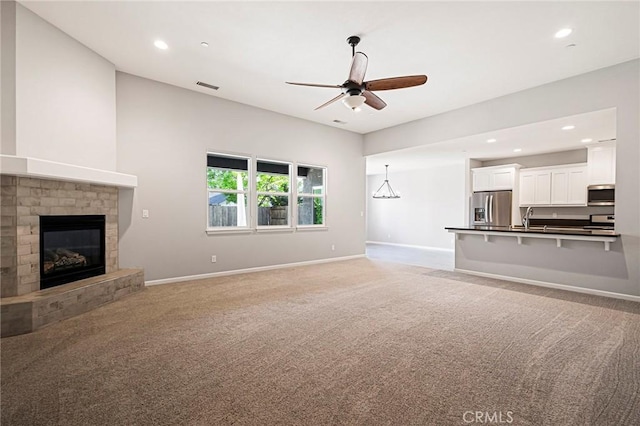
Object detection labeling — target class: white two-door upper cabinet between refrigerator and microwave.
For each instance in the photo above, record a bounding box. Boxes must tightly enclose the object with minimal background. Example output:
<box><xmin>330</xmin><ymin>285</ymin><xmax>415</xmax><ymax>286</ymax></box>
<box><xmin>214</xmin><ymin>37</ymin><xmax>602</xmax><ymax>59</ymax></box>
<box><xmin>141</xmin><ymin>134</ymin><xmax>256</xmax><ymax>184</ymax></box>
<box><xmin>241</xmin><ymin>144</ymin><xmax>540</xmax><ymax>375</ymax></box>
<box><xmin>520</xmin><ymin>164</ymin><xmax>587</xmax><ymax>207</ymax></box>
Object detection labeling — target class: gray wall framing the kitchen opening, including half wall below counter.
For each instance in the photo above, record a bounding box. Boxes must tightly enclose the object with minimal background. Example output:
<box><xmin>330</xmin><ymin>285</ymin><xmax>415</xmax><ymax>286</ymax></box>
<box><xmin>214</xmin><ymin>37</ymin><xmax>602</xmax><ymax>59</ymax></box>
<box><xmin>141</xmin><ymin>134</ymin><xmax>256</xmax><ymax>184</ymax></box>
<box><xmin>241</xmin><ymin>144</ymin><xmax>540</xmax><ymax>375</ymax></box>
<box><xmin>365</xmin><ymin>60</ymin><xmax>640</xmax><ymax>295</ymax></box>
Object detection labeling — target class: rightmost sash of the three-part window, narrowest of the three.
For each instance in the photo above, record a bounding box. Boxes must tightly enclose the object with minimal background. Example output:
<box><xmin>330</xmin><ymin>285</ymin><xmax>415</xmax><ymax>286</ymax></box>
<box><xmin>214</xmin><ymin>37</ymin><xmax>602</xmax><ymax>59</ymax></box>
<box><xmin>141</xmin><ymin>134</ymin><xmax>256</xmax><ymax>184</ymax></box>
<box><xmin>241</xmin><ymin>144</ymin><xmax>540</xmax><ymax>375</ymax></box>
<box><xmin>298</xmin><ymin>166</ymin><xmax>326</xmax><ymax>226</ymax></box>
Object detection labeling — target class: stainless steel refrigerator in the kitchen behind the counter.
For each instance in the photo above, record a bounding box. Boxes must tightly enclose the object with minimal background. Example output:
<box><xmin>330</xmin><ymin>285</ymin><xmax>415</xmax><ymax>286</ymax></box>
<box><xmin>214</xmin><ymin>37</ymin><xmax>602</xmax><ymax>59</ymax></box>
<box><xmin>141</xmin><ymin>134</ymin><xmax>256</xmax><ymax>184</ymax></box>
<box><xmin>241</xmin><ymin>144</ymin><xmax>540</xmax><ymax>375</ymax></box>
<box><xmin>469</xmin><ymin>191</ymin><xmax>512</xmax><ymax>226</ymax></box>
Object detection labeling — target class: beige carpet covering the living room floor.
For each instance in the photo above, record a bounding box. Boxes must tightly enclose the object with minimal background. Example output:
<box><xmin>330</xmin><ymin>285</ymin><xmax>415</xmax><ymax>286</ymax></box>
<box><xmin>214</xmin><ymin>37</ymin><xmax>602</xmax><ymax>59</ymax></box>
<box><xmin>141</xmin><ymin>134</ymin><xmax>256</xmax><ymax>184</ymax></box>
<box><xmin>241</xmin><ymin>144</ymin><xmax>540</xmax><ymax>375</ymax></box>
<box><xmin>1</xmin><ymin>259</ymin><xmax>640</xmax><ymax>426</ymax></box>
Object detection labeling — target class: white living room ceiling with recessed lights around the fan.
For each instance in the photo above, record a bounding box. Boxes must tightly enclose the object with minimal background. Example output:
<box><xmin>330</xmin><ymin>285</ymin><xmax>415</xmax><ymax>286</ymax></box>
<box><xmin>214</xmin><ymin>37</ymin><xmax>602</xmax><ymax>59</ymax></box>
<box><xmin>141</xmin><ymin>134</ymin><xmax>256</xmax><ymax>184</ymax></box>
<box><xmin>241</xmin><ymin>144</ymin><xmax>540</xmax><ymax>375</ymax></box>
<box><xmin>21</xmin><ymin>1</ymin><xmax>640</xmax><ymax>136</ymax></box>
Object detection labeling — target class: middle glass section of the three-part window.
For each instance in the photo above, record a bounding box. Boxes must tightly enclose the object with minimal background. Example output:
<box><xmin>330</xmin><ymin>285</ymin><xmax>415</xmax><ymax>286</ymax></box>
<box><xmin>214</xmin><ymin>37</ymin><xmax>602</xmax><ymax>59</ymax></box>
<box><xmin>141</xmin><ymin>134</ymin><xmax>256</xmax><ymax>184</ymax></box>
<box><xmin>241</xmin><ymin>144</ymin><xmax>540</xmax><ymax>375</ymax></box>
<box><xmin>256</xmin><ymin>160</ymin><xmax>291</xmax><ymax>226</ymax></box>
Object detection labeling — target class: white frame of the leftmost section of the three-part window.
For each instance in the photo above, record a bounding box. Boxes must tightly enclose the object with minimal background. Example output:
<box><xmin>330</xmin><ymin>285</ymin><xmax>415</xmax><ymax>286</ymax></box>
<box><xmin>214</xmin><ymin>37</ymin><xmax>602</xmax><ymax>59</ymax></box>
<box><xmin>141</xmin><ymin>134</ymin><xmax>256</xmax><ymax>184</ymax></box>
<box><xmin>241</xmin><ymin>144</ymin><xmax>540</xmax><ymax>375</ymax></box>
<box><xmin>205</xmin><ymin>151</ymin><xmax>254</xmax><ymax>234</ymax></box>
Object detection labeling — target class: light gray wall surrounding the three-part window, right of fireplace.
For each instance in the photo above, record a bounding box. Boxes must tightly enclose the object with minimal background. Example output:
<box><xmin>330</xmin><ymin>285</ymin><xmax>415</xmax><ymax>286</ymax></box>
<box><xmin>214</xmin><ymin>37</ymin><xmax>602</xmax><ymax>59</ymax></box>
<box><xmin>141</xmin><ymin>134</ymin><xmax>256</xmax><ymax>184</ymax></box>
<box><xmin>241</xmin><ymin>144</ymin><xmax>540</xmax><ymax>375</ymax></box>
<box><xmin>116</xmin><ymin>73</ymin><xmax>365</xmax><ymax>280</ymax></box>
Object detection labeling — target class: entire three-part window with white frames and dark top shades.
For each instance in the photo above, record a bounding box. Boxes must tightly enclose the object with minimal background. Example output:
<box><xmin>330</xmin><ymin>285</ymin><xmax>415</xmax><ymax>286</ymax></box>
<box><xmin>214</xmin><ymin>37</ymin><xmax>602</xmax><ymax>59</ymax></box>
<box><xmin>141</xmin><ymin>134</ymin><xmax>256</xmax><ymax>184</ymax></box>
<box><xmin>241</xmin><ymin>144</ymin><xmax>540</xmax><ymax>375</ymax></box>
<box><xmin>207</xmin><ymin>153</ymin><xmax>327</xmax><ymax>234</ymax></box>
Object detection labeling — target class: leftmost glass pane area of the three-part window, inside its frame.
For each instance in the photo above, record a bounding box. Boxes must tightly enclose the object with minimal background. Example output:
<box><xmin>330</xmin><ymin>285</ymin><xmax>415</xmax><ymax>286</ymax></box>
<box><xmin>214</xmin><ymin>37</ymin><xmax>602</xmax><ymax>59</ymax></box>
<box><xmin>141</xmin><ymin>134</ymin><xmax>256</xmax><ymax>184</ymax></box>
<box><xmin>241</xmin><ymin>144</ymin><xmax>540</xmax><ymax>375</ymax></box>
<box><xmin>207</xmin><ymin>154</ymin><xmax>250</xmax><ymax>229</ymax></box>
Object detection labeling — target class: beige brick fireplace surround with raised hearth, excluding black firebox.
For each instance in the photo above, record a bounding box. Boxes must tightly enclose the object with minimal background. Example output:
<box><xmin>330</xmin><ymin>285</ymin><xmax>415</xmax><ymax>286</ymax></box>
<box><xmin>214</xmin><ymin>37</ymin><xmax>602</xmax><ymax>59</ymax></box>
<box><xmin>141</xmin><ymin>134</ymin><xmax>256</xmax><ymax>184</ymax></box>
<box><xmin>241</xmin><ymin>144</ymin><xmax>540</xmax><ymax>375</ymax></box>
<box><xmin>0</xmin><ymin>175</ymin><xmax>144</xmax><ymax>336</ymax></box>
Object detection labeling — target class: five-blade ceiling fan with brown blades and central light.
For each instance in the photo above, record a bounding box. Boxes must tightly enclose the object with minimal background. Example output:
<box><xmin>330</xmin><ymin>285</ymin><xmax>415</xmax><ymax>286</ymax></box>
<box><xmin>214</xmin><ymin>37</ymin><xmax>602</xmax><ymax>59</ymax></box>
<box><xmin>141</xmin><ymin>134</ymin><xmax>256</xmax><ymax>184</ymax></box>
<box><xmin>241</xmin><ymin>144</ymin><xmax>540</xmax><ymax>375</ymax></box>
<box><xmin>286</xmin><ymin>36</ymin><xmax>427</xmax><ymax>111</ymax></box>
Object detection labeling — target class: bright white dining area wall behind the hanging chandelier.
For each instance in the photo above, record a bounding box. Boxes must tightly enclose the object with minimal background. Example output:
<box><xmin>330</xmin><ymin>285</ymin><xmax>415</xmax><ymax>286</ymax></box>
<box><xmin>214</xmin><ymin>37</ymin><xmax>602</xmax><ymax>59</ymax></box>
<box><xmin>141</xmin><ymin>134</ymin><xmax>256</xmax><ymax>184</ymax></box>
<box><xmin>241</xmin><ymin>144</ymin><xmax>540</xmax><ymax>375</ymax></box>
<box><xmin>367</xmin><ymin>161</ymin><xmax>466</xmax><ymax>250</ymax></box>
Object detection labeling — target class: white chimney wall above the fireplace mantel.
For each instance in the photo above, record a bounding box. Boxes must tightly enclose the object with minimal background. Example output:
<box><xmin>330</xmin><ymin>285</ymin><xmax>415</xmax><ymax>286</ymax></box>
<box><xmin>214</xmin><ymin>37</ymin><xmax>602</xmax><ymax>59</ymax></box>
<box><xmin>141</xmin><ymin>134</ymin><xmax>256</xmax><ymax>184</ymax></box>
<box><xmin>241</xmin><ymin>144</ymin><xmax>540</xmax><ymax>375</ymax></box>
<box><xmin>13</xmin><ymin>4</ymin><xmax>116</xmax><ymax>171</ymax></box>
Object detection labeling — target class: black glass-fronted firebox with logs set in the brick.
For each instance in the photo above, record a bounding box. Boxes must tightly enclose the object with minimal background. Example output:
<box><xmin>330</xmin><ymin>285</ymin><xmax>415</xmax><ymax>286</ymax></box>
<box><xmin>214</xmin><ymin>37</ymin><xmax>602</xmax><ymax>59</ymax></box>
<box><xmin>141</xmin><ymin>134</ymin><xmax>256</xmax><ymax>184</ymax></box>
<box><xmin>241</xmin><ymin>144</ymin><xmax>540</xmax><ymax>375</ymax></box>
<box><xmin>40</xmin><ymin>215</ymin><xmax>105</xmax><ymax>289</ymax></box>
